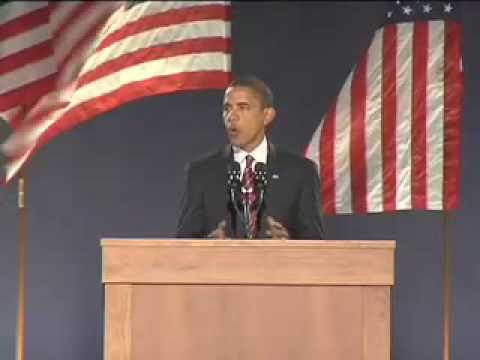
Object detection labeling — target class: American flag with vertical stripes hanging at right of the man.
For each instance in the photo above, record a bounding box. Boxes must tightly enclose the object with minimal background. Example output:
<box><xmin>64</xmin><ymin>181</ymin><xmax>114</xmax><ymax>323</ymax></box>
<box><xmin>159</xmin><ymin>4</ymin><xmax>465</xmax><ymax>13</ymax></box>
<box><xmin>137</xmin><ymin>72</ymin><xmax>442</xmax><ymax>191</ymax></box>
<box><xmin>305</xmin><ymin>1</ymin><xmax>464</xmax><ymax>214</ymax></box>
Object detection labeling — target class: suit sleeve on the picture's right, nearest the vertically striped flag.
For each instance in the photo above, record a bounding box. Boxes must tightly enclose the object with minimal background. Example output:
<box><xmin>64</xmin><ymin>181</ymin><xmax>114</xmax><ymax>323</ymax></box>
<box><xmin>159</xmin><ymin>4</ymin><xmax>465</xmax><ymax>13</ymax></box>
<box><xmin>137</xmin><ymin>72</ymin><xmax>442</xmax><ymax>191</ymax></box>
<box><xmin>295</xmin><ymin>162</ymin><xmax>324</xmax><ymax>240</ymax></box>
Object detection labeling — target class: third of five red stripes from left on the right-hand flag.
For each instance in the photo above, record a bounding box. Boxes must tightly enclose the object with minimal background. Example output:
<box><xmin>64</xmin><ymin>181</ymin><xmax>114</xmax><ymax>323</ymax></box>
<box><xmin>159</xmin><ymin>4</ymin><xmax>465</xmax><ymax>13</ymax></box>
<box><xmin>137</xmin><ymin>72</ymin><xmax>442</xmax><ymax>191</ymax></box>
<box><xmin>382</xmin><ymin>25</ymin><xmax>397</xmax><ymax>211</ymax></box>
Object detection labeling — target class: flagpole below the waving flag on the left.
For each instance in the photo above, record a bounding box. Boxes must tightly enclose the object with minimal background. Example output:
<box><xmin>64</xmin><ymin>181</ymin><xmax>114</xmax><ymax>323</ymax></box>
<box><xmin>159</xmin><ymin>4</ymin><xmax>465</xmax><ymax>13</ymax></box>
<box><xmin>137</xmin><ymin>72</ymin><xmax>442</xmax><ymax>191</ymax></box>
<box><xmin>16</xmin><ymin>171</ymin><xmax>27</xmax><ymax>360</ymax></box>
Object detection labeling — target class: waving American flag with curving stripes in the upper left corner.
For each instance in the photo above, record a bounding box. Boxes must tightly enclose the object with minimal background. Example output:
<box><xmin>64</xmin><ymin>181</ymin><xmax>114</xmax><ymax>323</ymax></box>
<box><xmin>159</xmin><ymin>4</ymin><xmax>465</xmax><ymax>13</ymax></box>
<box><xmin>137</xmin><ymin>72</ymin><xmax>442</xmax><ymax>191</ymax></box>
<box><xmin>0</xmin><ymin>1</ymin><xmax>231</xmax><ymax>182</ymax></box>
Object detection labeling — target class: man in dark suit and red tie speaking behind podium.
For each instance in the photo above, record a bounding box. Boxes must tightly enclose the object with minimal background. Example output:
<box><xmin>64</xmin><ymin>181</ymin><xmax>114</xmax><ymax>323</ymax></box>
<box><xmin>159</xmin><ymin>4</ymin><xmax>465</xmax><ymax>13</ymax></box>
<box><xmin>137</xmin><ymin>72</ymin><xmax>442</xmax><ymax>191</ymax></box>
<box><xmin>177</xmin><ymin>77</ymin><xmax>323</xmax><ymax>239</ymax></box>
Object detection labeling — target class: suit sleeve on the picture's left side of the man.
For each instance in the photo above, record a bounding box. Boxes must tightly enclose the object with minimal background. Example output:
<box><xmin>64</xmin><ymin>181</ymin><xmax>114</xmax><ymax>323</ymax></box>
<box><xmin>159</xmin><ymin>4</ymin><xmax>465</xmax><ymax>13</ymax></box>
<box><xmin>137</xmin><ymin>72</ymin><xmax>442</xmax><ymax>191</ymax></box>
<box><xmin>176</xmin><ymin>164</ymin><xmax>206</xmax><ymax>238</ymax></box>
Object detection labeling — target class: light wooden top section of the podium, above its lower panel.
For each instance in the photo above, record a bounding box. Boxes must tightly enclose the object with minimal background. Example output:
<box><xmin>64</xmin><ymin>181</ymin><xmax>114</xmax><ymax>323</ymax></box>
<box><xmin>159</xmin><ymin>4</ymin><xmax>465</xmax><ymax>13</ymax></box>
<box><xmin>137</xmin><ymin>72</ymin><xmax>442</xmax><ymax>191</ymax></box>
<box><xmin>101</xmin><ymin>239</ymin><xmax>395</xmax><ymax>286</ymax></box>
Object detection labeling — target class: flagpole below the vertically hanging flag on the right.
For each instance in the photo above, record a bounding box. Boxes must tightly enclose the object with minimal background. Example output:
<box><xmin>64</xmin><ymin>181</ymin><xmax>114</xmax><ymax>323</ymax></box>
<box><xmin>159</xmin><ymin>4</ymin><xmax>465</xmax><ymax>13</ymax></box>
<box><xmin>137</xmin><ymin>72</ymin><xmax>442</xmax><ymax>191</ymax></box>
<box><xmin>442</xmin><ymin>211</ymin><xmax>452</xmax><ymax>360</ymax></box>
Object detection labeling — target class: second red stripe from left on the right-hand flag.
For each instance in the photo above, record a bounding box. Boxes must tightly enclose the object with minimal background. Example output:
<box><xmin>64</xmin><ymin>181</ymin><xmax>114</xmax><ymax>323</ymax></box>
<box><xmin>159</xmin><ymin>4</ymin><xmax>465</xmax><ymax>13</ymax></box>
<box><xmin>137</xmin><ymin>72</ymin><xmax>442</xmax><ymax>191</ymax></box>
<box><xmin>350</xmin><ymin>54</ymin><xmax>367</xmax><ymax>214</ymax></box>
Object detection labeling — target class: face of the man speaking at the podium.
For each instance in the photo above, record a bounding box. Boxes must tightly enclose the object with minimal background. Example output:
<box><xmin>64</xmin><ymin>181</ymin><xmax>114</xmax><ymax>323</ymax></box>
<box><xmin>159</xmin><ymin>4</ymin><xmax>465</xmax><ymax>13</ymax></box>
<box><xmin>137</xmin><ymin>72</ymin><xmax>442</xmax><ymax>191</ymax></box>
<box><xmin>223</xmin><ymin>86</ymin><xmax>275</xmax><ymax>152</ymax></box>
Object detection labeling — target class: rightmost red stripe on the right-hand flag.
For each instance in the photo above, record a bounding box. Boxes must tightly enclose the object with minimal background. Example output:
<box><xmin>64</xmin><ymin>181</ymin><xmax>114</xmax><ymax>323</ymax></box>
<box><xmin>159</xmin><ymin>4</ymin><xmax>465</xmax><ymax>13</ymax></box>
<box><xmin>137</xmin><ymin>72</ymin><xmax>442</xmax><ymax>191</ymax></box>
<box><xmin>443</xmin><ymin>22</ymin><xmax>464</xmax><ymax>210</ymax></box>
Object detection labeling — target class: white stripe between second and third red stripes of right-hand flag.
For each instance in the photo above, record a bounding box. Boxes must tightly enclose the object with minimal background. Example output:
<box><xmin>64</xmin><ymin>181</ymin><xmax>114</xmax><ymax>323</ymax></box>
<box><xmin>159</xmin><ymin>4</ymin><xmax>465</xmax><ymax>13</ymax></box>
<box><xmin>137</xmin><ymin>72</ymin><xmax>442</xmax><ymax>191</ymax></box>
<box><xmin>364</xmin><ymin>29</ymin><xmax>383</xmax><ymax>212</ymax></box>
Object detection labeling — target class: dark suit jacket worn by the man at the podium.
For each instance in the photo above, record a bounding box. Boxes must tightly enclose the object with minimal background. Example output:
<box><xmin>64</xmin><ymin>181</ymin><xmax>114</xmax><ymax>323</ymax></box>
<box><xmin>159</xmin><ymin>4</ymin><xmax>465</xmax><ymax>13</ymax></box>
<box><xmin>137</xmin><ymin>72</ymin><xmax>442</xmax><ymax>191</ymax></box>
<box><xmin>177</xmin><ymin>144</ymin><xmax>323</xmax><ymax>239</ymax></box>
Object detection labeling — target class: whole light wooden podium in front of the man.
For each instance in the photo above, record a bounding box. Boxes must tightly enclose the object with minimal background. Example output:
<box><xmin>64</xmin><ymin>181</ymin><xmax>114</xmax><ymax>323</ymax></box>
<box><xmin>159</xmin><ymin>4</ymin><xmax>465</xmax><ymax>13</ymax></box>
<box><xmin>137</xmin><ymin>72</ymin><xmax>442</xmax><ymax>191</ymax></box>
<box><xmin>101</xmin><ymin>239</ymin><xmax>395</xmax><ymax>360</ymax></box>
